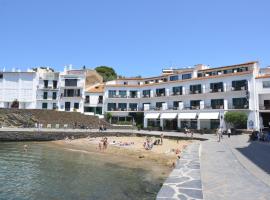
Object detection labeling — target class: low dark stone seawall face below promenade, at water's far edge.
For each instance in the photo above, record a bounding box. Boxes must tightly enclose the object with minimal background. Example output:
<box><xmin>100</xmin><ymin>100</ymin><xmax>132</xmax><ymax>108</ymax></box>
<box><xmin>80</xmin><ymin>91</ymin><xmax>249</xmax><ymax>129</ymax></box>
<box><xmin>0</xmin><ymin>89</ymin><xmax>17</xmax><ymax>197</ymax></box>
<box><xmin>0</xmin><ymin>131</ymin><xmax>134</xmax><ymax>141</ymax></box>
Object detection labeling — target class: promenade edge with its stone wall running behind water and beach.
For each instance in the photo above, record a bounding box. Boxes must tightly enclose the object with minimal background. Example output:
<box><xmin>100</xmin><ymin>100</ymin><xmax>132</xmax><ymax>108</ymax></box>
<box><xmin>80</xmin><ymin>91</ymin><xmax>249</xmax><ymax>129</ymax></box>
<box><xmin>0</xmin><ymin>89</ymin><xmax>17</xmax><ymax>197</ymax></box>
<box><xmin>0</xmin><ymin>128</ymin><xmax>209</xmax><ymax>141</ymax></box>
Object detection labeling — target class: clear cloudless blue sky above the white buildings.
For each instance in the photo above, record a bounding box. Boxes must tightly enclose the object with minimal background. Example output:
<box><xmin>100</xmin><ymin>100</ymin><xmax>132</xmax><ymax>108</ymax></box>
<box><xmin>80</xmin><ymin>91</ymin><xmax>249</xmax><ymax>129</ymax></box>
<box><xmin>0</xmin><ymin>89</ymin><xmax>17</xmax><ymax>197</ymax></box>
<box><xmin>0</xmin><ymin>0</ymin><xmax>270</xmax><ymax>77</ymax></box>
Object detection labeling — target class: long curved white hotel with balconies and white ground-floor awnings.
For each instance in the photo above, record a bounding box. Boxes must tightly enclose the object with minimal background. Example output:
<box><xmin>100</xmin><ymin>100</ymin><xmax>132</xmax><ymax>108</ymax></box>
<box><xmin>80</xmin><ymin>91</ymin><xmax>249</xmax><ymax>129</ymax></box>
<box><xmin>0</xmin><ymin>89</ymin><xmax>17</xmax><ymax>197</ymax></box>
<box><xmin>104</xmin><ymin>62</ymin><xmax>259</xmax><ymax>130</ymax></box>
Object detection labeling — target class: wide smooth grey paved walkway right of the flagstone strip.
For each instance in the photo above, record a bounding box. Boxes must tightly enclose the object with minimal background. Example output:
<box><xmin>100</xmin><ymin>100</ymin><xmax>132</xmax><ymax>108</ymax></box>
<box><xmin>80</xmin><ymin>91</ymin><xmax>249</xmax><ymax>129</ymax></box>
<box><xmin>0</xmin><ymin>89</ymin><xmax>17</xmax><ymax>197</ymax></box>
<box><xmin>201</xmin><ymin>136</ymin><xmax>270</xmax><ymax>200</ymax></box>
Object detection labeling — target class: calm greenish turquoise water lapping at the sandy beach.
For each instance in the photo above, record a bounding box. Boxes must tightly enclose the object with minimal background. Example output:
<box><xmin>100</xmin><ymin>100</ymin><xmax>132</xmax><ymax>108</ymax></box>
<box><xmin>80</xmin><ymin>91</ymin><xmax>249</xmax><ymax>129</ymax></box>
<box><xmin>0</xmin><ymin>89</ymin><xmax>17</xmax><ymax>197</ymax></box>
<box><xmin>0</xmin><ymin>142</ymin><xmax>163</xmax><ymax>200</ymax></box>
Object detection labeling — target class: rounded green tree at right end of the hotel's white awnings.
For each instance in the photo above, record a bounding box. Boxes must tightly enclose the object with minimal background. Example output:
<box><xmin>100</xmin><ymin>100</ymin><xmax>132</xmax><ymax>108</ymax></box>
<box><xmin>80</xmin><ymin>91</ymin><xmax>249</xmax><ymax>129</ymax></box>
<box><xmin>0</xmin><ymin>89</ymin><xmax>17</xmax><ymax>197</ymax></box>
<box><xmin>224</xmin><ymin>112</ymin><xmax>247</xmax><ymax>128</ymax></box>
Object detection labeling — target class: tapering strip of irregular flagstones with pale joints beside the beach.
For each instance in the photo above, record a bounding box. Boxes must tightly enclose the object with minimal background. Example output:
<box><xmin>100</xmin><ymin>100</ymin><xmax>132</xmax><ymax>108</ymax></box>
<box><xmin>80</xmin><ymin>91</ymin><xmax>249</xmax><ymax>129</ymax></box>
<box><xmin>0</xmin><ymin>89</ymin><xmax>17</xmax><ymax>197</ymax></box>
<box><xmin>157</xmin><ymin>143</ymin><xmax>203</xmax><ymax>200</ymax></box>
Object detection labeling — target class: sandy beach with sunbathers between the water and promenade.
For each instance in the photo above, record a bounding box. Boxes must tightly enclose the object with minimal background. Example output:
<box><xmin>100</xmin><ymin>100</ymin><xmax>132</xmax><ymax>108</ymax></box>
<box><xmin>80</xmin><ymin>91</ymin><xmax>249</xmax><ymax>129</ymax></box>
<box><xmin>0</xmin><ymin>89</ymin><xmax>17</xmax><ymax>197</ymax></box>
<box><xmin>53</xmin><ymin>136</ymin><xmax>192</xmax><ymax>169</ymax></box>
